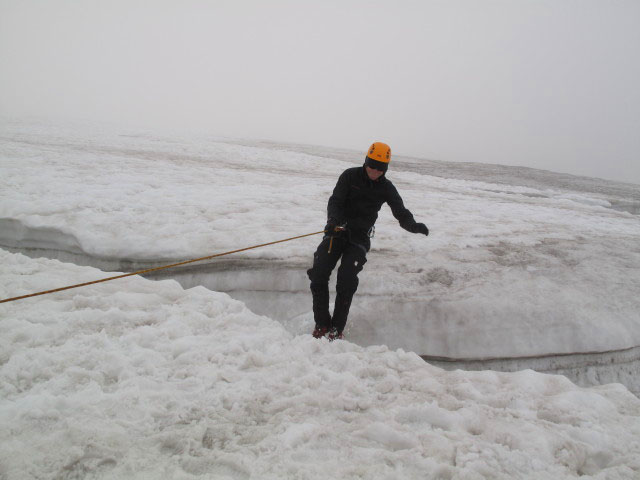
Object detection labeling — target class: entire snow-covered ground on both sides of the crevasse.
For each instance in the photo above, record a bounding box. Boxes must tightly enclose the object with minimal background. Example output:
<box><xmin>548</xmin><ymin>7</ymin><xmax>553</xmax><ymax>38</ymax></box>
<box><xmin>0</xmin><ymin>119</ymin><xmax>640</xmax><ymax>480</ymax></box>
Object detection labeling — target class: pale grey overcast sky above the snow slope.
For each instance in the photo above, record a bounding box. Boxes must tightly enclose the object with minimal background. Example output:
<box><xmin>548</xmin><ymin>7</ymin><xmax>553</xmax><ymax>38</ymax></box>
<box><xmin>0</xmin><ymin>0</ymin><xmax>640</xmax><ymax>183</ymax></box>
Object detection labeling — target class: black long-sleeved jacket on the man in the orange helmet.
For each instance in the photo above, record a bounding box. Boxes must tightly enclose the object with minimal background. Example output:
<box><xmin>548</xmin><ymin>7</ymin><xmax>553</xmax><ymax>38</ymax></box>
<box><xmin>327</xmin><ymin>167</ymin><xmax>416</xmax><ymax>251</ymax></box>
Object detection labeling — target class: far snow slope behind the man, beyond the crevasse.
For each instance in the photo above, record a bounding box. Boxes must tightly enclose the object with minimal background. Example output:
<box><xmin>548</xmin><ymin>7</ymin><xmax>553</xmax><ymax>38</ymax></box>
<box><xmin>0</xmin><ymin>121</ymin><xmax>640</xmax><ymax>359</ymax></box>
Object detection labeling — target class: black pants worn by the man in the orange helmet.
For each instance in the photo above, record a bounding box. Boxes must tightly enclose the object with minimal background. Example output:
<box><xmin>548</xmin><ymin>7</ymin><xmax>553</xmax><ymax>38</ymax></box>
<box><xmin>307</xmin><ymin>237</ymin><xmax>367</xmax><ymax>332</ymax></box>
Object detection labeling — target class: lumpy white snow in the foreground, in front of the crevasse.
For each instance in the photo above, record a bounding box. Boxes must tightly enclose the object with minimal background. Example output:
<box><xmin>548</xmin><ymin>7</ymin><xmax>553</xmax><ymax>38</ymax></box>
<box><xmin>0</xmin><ymin>250</ymin><xmax>640</xmax><ymax>480</ymax></box>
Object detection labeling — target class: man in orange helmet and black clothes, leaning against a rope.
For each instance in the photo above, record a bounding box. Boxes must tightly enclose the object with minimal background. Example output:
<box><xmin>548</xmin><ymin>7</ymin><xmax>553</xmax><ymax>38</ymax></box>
<box><xmin>307</xmin><ymin>142</ymin><xmax>429</xmax><ymax>340</ymax></box>
